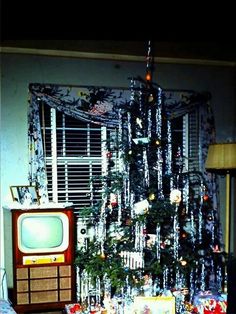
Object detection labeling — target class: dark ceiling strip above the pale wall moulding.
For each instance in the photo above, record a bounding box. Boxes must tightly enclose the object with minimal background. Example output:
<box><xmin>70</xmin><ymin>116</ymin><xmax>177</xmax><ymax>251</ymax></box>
<box><xmin>1</xmin><ymin>40</ymin><xmax>236</xmax><ymax>62</ymax></box>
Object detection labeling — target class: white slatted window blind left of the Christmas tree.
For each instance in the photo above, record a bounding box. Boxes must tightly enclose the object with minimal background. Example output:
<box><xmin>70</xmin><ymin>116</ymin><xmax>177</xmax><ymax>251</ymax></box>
<box><xmin>41</xmin><ymin>106</ymin><xmax>107</xmax><ymax>210</ymax></box>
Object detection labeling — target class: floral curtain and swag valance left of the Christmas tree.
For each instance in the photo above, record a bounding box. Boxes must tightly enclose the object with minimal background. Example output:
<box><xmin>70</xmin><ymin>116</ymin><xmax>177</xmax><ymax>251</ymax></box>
<box><xmin>28</xmin><ymin>84</ymin><xmax>130</xmax><ymax>203</ymax></box>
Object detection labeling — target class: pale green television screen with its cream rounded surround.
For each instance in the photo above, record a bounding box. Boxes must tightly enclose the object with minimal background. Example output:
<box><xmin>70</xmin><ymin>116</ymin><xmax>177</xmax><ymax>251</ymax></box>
<box><xmin>17</xmin><ymin>212</ymin><xmax>69</xmax><ymax>254</ymax></box>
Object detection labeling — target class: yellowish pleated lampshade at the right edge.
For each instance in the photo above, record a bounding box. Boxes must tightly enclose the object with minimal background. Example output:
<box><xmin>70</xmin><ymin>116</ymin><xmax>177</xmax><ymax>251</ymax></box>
<box><xmin>205</xmin><ymin>143</ymin><xmax>236</xmax><ymax>170</ymax></box>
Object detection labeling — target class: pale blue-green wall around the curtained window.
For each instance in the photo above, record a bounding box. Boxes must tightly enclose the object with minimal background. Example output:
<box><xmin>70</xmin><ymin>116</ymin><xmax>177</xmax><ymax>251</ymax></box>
<box><xmin>0</xmin><ymin>54</ymin><xmax>236</xmax><ymax>294</ymax></box>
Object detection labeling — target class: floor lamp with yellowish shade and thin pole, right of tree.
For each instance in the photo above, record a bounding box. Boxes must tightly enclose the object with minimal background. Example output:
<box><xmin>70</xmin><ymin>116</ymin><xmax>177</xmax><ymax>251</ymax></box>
<box><xmin>205</xmin><ymin>143</ymin><xmax>236</xmax><ymax>253</ymax></box>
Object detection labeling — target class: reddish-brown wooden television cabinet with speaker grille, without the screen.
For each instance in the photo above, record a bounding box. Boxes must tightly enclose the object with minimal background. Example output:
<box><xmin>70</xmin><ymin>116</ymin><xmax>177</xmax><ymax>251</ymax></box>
<box><xmin>11</xmin><ymin>208</ymin><xmax>76</xmax><ymax>313</ymax></box>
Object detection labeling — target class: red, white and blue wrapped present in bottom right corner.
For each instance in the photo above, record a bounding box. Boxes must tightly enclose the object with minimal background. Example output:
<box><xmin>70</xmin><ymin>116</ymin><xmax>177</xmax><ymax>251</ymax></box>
<box><xmin>193</xmin><ymin>291</ymin><xmax>227</xmax><ymax>314</ymax></box>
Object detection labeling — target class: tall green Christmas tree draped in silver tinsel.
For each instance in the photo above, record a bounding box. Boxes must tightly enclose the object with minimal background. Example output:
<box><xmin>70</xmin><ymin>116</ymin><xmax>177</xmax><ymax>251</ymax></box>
<box><xmin>76</xmin><ymin>42</ymin><xmax>224</xmax><ymax>313</ymax></box>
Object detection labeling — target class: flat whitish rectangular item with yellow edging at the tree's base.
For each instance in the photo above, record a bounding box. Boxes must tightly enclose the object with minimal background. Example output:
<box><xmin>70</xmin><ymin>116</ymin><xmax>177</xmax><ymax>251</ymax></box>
<box><xmin>132</xmin><ymin>296</ymin><xmax>175</xmax><ymax>314</ymax></box>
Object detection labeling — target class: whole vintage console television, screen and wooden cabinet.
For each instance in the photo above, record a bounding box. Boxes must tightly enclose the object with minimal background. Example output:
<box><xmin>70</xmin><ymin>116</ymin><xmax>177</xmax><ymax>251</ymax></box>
<box><xmin>11</xmin><ymin>208</ymin><xmax>76</xmax><ymax>313</ymax></box>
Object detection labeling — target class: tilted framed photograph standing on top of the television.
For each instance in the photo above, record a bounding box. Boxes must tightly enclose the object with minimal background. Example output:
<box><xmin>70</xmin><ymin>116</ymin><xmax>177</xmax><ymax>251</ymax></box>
<box><xmin>10</xmin><ymin>185</ymin><xmax>39</xmax><ymax>206</ymax></box>
